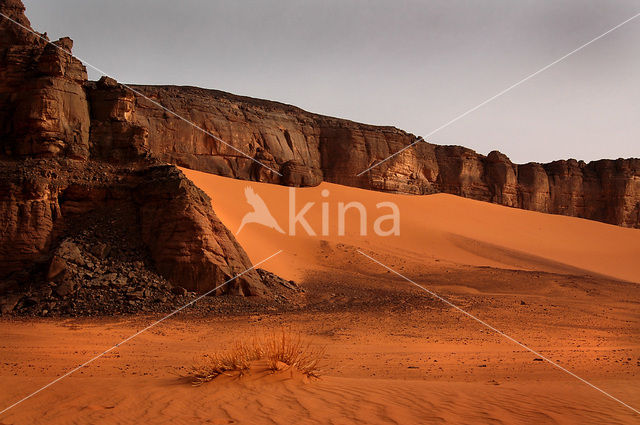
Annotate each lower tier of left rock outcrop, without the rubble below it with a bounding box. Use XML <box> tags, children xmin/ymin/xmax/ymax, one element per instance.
<box><xmin>0</xmin><ymin>158</ymin><xmax>265</xmax><ymax>295</ymax></box>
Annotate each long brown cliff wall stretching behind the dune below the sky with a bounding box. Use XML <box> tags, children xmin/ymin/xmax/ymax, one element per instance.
<box><xmin>100</xmin><ymin>82</ymin><xmax>640</xmax><ymax>227</ymax></box>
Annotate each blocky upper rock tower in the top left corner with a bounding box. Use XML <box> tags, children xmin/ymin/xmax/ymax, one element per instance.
<box><xmin>0</xmin><ymin>0</ymin><xmax>90</xmax><ymax>158</ymax></box>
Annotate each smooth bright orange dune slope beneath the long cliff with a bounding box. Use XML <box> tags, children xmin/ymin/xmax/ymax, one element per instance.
<box><xmin>183</xmin><ymin>169</ymin><xmax>640</xmax><ymax>282</ymax></box>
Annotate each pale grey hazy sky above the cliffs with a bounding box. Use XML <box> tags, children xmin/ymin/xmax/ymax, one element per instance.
<box><xmin>24</xmin><ymin>0</ymin><xmax>640</xmax><ymax>162</ymax></box>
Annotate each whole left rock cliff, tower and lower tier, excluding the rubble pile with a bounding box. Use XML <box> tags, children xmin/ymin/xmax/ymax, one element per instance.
<box><xmin>0</xmin><ymin>0</ymin><xmax>265</xmax><ymax>302</ymax></box>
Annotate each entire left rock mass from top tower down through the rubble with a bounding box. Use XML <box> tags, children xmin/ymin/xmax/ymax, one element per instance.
<box><xmin>0</xmin><ymin>0</ymin><xmax>298</xmax><ymax>314</ymax></box>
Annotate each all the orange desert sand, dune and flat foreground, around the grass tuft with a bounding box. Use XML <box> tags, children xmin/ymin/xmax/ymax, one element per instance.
<box><xmin>0</xmin><ymin>170</ymin><xmax>640</xmax><ymax>424</ymax></box>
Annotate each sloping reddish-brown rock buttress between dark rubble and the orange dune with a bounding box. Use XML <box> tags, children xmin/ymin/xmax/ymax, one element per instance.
<box><xmin>136</xmin><ymin>166</ymin><xmax>265</xmax><ymax>295</ymax></box>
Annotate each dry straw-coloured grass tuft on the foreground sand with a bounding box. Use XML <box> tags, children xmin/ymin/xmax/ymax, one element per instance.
<box><xmin>187</xmin><ymin>331</ymin><xmax>325</xmax><ymax>385</ymax></box>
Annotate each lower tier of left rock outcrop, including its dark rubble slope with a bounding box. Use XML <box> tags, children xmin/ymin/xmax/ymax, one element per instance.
<box><xmin>0</xmin><ymin>159</ymin><xmax>302</xmax><ymax>315</ymax></box>
